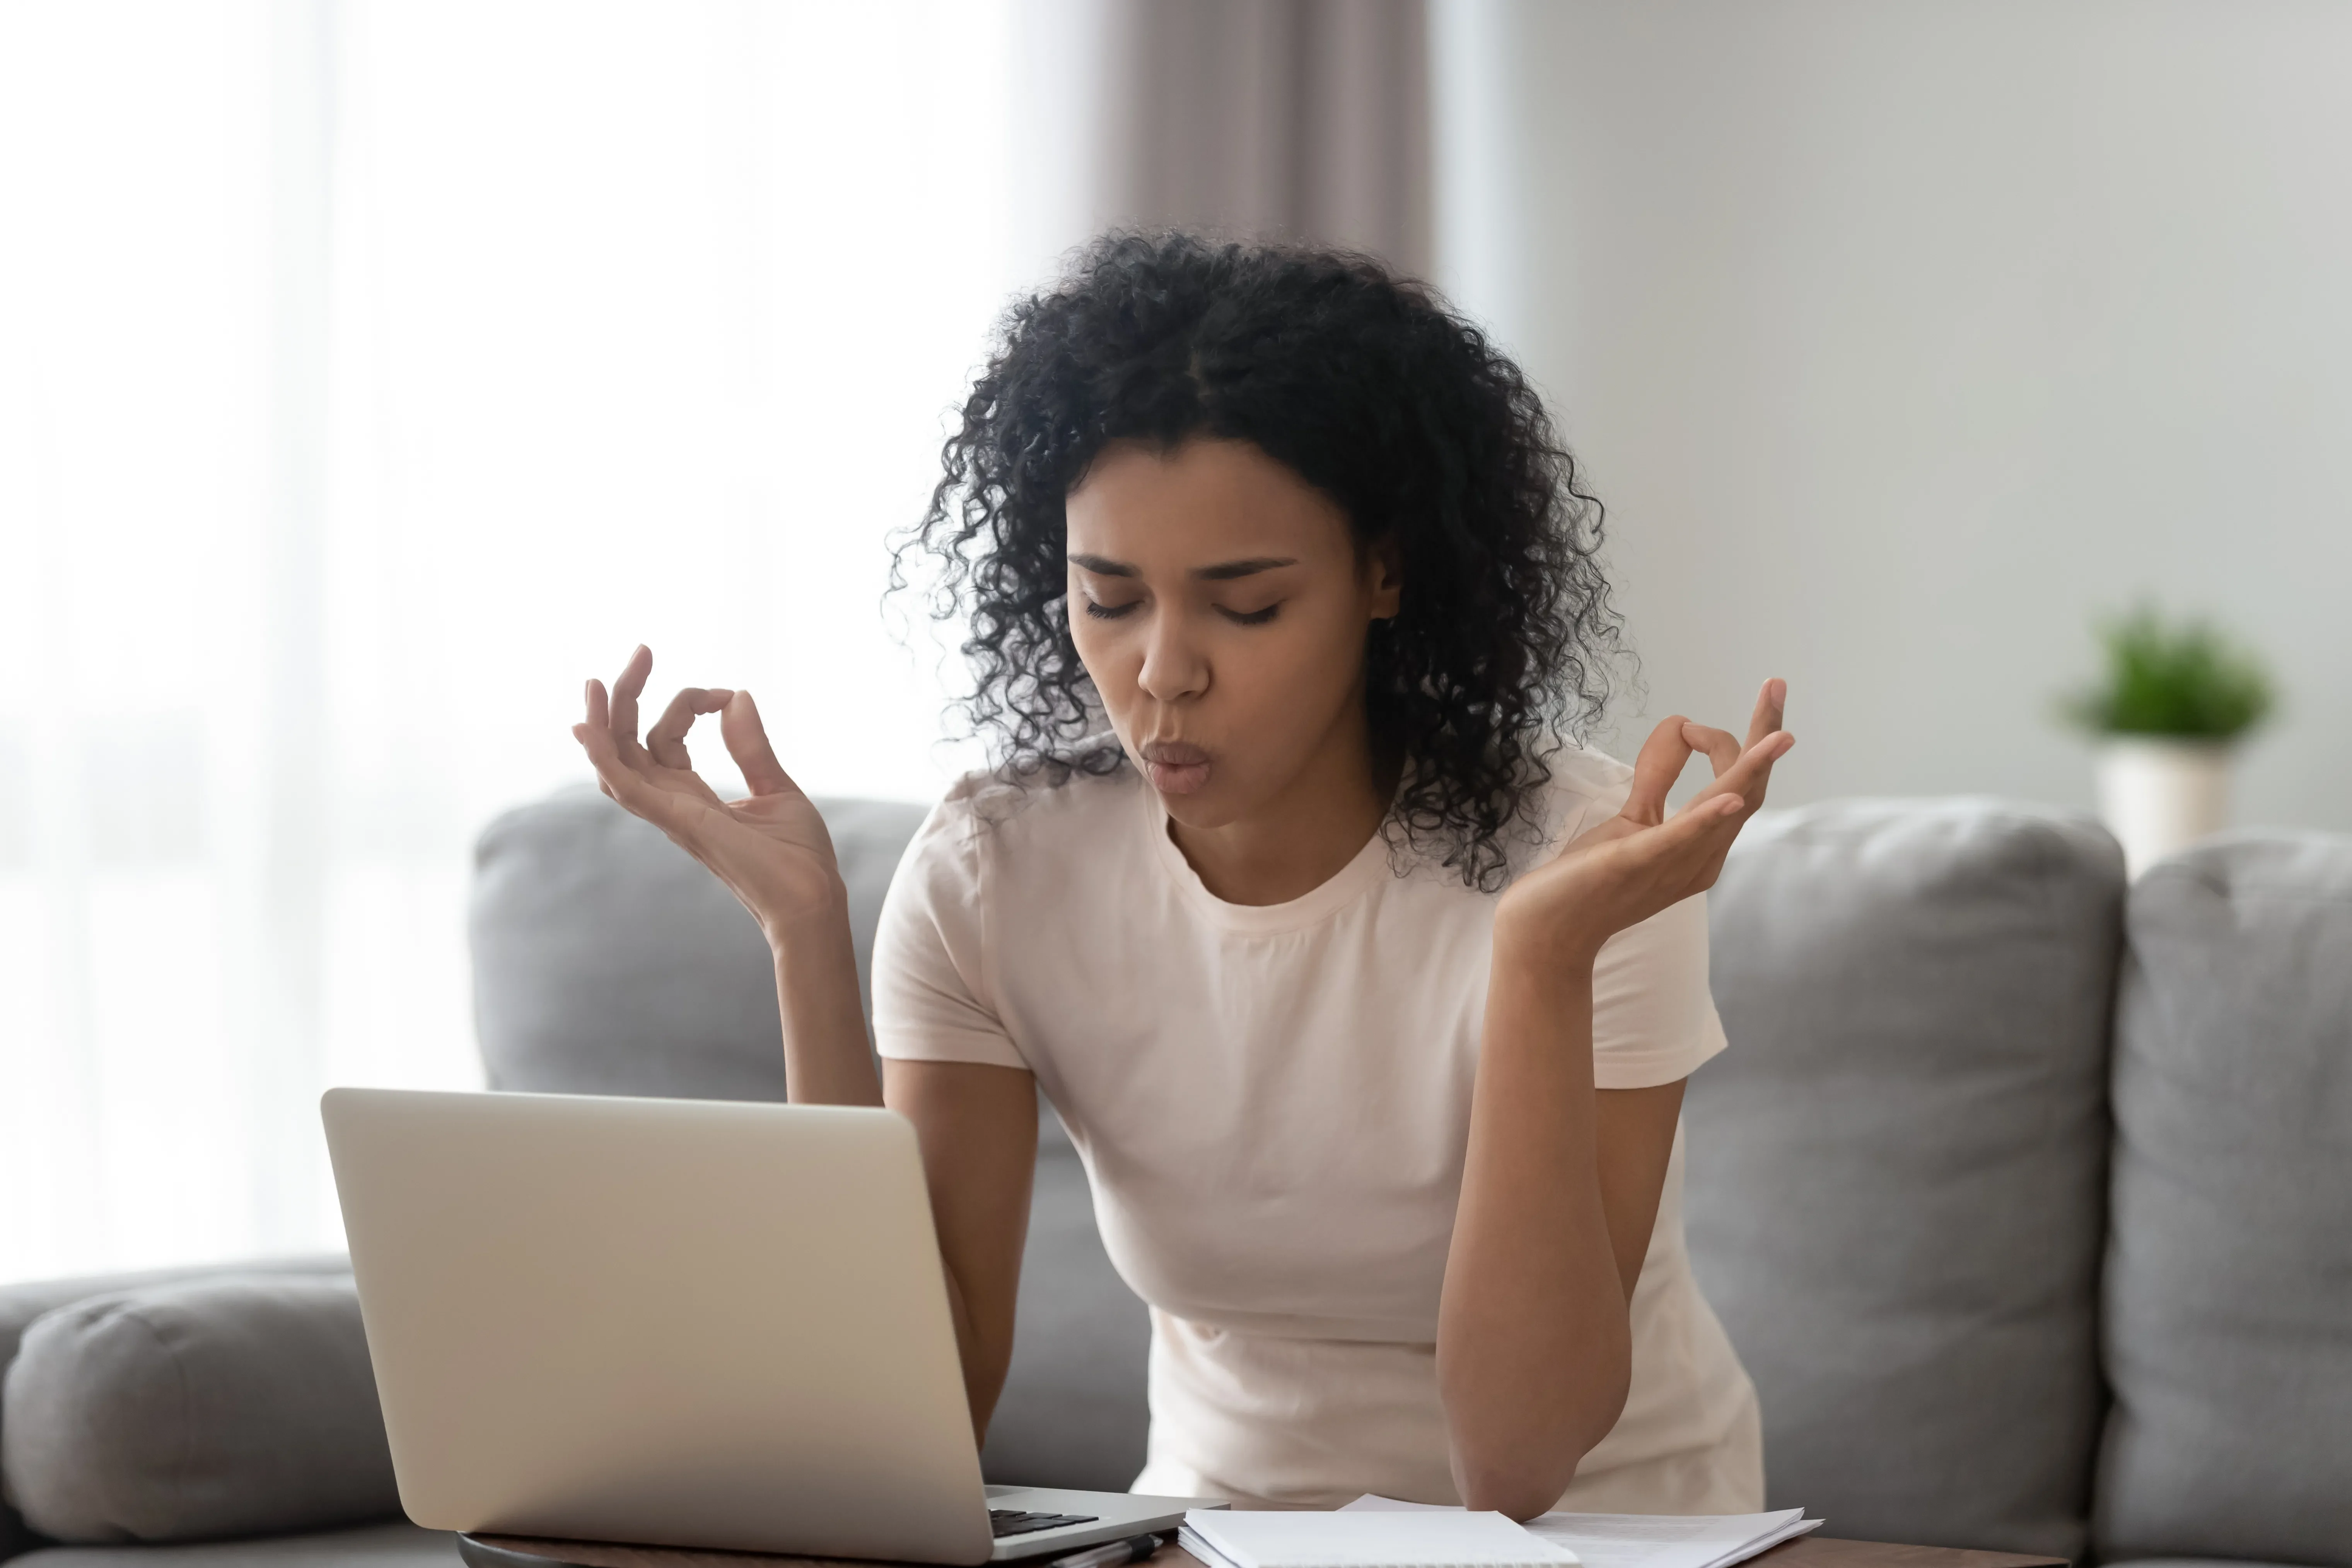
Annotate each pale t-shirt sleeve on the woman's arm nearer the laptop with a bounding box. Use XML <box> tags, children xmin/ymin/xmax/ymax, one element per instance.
<box><xmin>872</xmin><ymin>792</ymin><xmax>1028</xmax><ymax>1070</ymax></box>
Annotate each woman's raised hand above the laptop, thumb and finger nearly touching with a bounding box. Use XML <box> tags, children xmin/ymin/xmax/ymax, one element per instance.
<box><xmin>572</xmin><ymin>647</ymin><xmax>847</xmax><ymax>952</ymax></box>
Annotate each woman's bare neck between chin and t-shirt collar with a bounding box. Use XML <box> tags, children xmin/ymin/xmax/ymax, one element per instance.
<box><xmin>1169</xmin><ymin>703</ymin><xmax>1397</xmax><ymax>905</ymax></box>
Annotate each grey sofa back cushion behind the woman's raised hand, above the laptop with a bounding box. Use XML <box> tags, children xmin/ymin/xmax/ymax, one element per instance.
<box><xmin>470</xmin><ymin>785</ymin><xmax>924</xmax><ymax>1100</ymax></box>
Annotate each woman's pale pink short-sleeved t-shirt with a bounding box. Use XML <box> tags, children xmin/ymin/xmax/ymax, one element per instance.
<box><xmin>872</xmin><ymin>750</ymin><xmax>1764</xmax><ymax>1514</ymax></box>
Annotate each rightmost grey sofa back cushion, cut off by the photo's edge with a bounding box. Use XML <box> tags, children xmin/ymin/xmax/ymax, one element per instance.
<box><xmin>2098</xmin><ymin>832</ymin><xmax>2352</xmax><ymax>1566</ymax></box>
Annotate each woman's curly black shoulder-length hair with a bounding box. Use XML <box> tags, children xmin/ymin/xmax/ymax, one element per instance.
<box><xmin>891</xmin><ymin>233</ymin><xmax>1623</xmax><ymax>889</ymax></box>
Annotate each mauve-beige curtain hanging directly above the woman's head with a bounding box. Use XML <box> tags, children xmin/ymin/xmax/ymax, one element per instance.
<box><xmin>1016</xmin><ymin>0</ymin><xmax>1430</xmax><ymax>273</ymax></box>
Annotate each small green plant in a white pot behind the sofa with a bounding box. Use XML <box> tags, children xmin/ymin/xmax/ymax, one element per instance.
<box><xmin>2060</xmin><ymin>604</ymin><xmax>2274</xmax><ymax>877</ymax></box>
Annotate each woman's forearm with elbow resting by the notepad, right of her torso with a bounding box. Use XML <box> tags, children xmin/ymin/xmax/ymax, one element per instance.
<box><xmin>1437</xmin><ymin>943</ymin><xmax>1632</xmax><ymax>1519</ymax></box>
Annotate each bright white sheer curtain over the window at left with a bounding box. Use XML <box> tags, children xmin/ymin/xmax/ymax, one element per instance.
<box><xmin>0</xmin><ymin>0</ymin><xmax>1030</xmax><ymax>1279</ymax></box>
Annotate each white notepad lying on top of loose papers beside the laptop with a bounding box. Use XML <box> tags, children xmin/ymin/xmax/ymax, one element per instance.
<box><xmin>1195</xmin><ymin>1509</ymin><xmax>1576</xmax><ymax>1568</ymax></box>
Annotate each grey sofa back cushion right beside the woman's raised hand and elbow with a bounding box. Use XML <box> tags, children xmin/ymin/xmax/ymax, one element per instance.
<box><xmin>1686</xmin><ymin>799</ymin><xmax>2124</xmax><ymax>1561</ymax></box>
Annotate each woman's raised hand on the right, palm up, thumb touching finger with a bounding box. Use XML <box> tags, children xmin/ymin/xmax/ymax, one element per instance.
<box><xmin>1496</xmin><ymin>679</ymin><xmax>1797</xmax><ymax>961</ymax></box>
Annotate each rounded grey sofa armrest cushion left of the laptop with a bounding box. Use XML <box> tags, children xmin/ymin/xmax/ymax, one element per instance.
<box><xmin>0</xmin><ymin>1274</ymin><xmax>400</xmax><ymax>1542</ymax></box>
